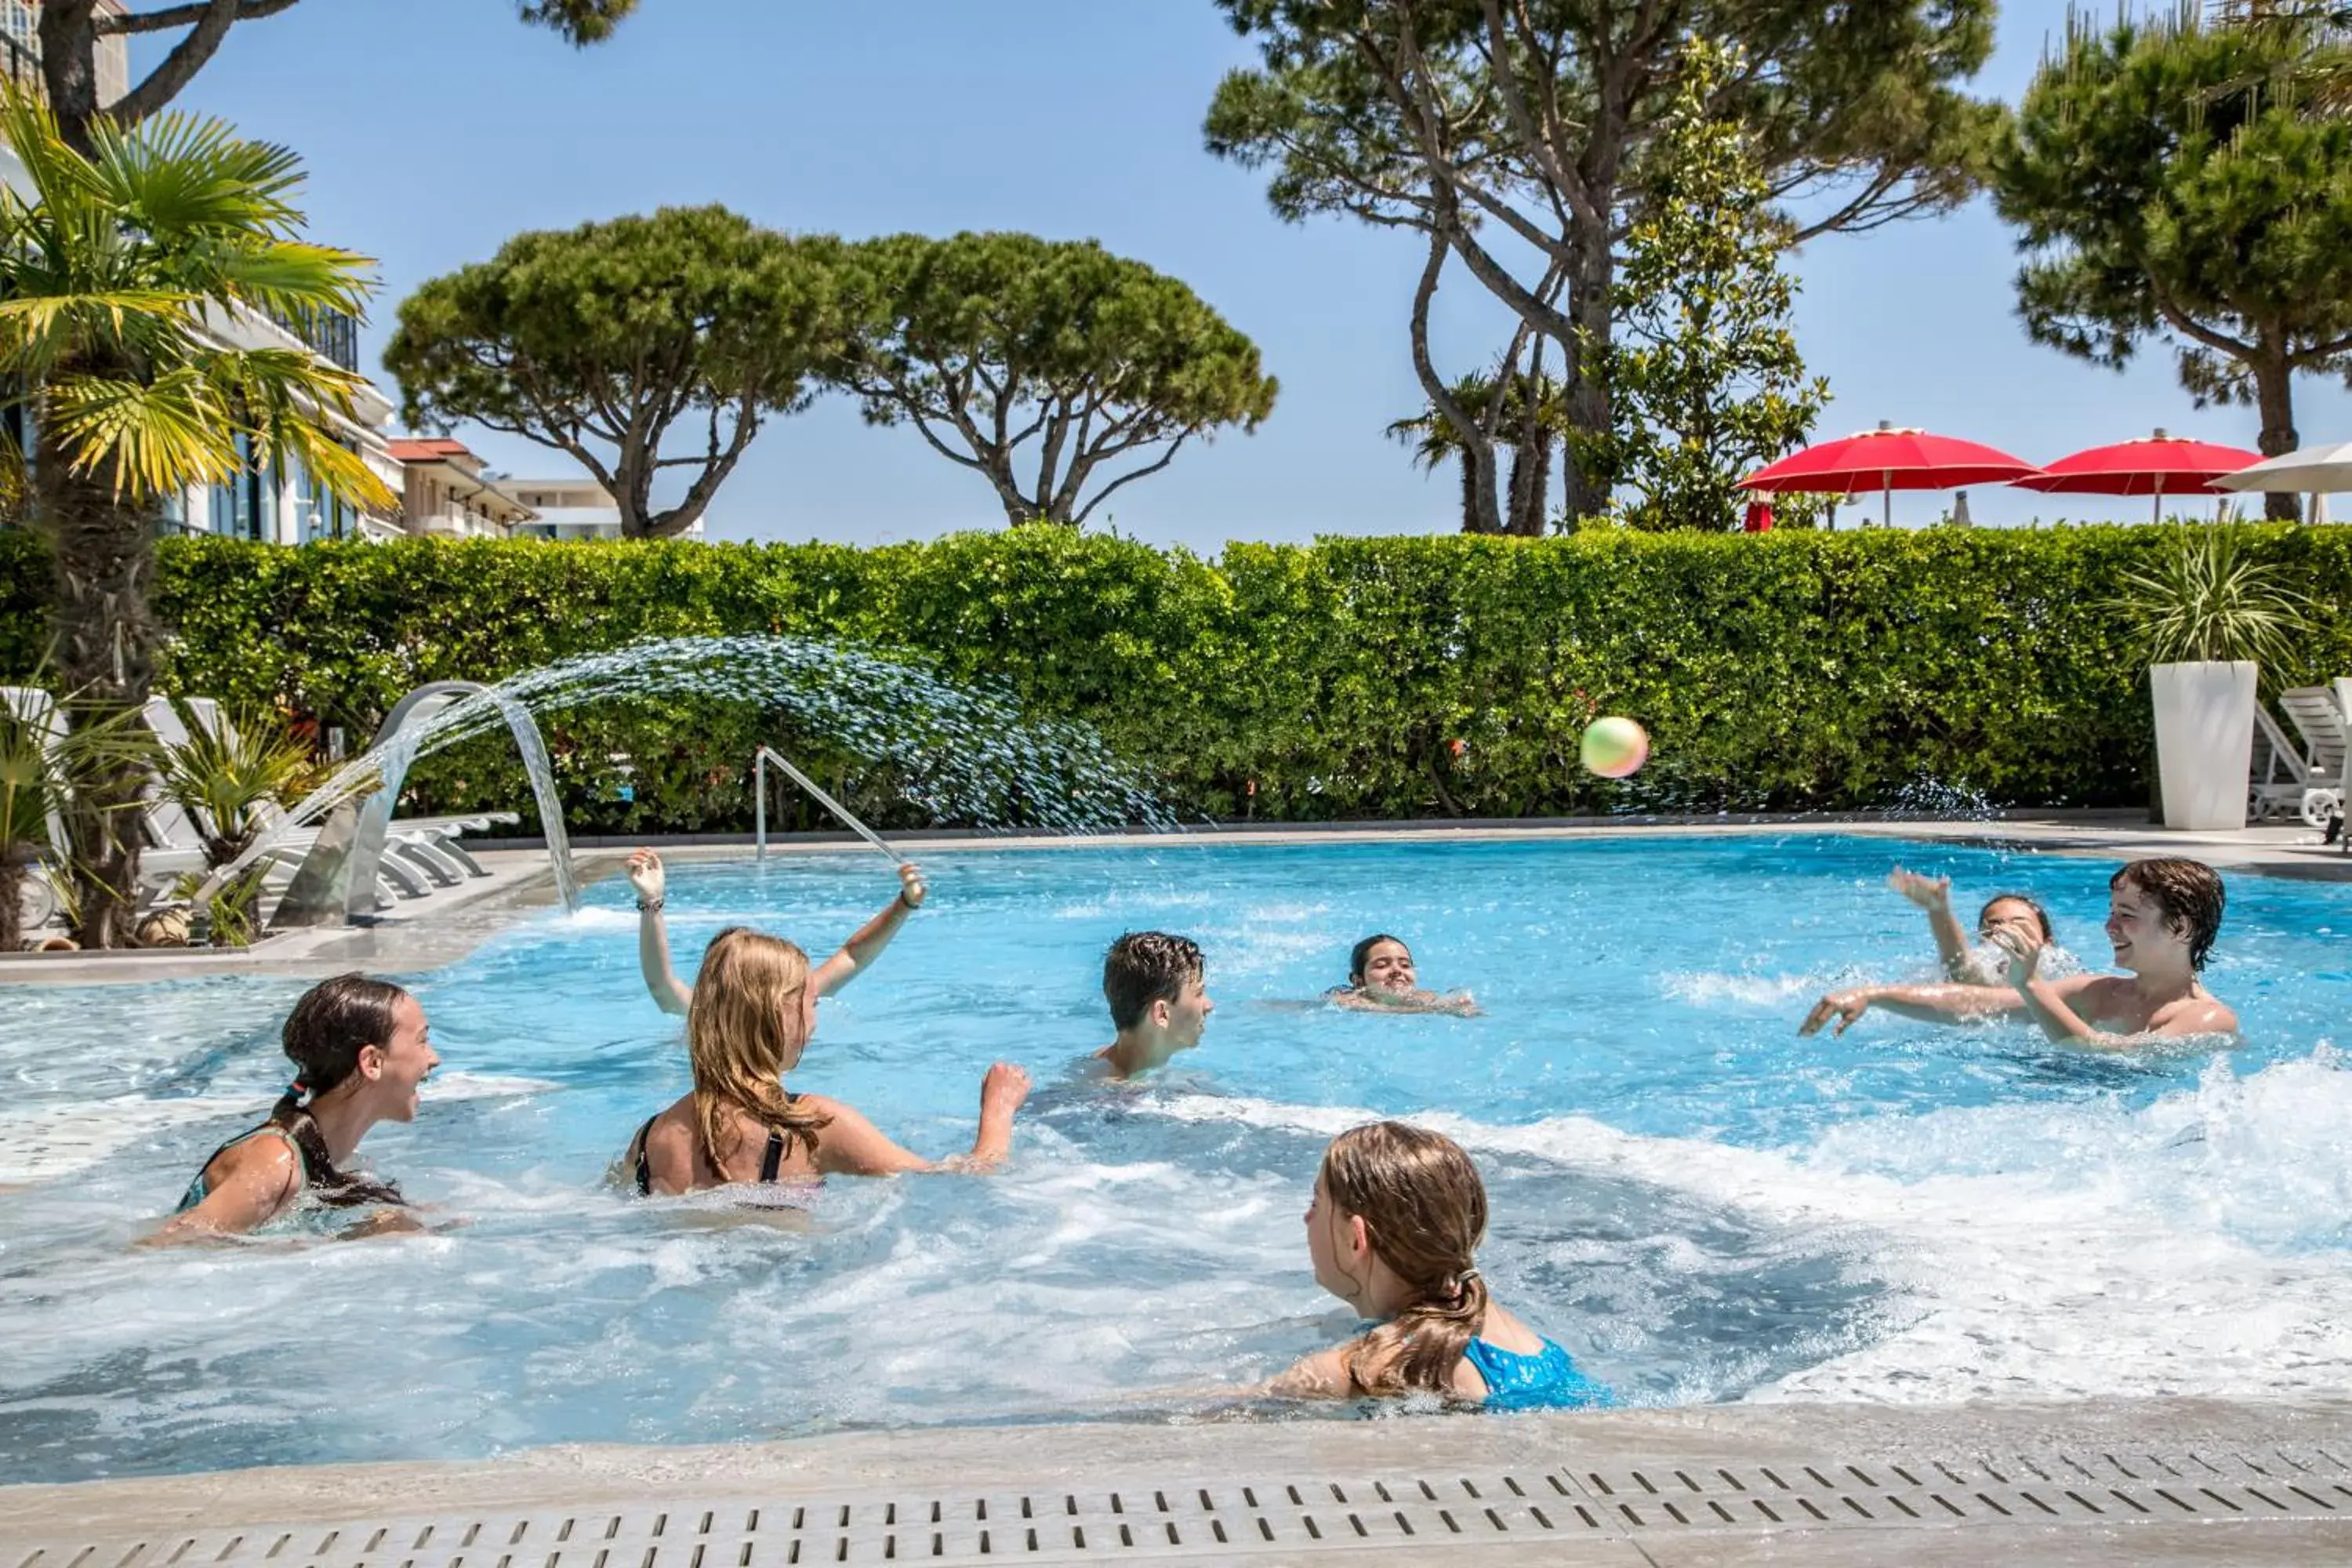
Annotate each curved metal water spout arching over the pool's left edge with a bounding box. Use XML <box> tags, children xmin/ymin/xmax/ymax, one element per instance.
<box><xmin>270</xmin><ymin>682</ymin><xmax>581</xmax><ymax>926</ymax></box>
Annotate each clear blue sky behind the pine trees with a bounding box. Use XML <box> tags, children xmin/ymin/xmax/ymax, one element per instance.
<box><xmin>156</xmin><ymin>0</ymin><xmax>2352</xmax><ymax>550</ymax></box>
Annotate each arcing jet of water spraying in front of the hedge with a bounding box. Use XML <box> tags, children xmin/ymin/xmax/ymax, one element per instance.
<box><xmin>219</xmin><ymin>635</ymin><xmax>1181</xmax><ymax>902</ymax></box>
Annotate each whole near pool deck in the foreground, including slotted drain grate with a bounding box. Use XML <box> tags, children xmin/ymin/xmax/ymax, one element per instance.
<box><xmin>0</xmin><ymin>1401</ymin><xmax>2352</xmax><ymax>1568</ymax></box>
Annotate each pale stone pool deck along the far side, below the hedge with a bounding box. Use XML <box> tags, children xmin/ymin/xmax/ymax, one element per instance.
<box><xmin>0</xmin><ymin>811</ymin><xmax>2352</xmax><ymax>987</ymax></box>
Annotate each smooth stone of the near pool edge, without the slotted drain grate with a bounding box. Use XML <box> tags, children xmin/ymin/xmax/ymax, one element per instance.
<box><xmin>0</xmin><ymin>1399</ymin><xmax>2352</xmax><ymax>1566</ymax></box>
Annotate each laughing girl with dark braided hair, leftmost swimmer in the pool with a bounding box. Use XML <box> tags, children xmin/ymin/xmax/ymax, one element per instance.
<box><xmin>158</xmin><ymin>975</ymin><xmax>440</xmax><ymax>1241</ymax></box>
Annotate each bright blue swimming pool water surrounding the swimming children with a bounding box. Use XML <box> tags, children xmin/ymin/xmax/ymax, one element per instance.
<box><xmin>0</xmin><ymin>834</ymin><xmax>2352</xmax><ymax>1481</ymax></box>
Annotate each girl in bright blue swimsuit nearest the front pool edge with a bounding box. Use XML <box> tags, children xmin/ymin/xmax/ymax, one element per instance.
<box><xmin>1268</xmin><ymin>1121</ymin><xmax>1611</xmax><ymax>1410</ymax></box>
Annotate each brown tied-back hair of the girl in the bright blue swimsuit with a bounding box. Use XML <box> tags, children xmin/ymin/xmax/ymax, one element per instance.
<box><xmin>1322</xmin><ymin>1121</ymin><xmax>1486</xmax><ymax>1394</ymax></box>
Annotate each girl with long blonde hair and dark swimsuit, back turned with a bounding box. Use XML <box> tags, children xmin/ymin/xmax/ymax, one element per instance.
<box><xmin>621</xmin><ymin>926</ymin><xmax>1030</xmax><ymax>1196</ymax></box>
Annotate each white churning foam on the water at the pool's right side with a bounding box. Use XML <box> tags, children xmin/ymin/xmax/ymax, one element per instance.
<box><xmin>1160</xmin><ymin>1048</ymin><xmax>2352</xmax><ymax>1401</ymax></box>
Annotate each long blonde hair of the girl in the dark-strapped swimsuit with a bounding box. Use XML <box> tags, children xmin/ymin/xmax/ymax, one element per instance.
<box><xmin>687</xmin><ymin>926</ymin><xmax>833</xmax><ymax>1178</ymax></box>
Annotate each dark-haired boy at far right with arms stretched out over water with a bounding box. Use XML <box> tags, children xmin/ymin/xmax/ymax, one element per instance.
<box><xmin>1797</xmin><ymin>858</ymin><xmax>2237</xmax><ymax>1051</ymax></box>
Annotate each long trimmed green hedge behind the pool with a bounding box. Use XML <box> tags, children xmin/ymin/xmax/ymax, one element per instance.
<box><xmin>0</xmin><ymin>527</ymin><xmax>2352</xmax><ymax>832</ymax></box>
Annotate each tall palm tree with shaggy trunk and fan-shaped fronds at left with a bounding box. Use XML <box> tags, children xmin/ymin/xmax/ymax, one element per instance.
<box><xmin>0</xmin><ymin>89</ymin><xmax>390</xmax><ymax>947</ymax></box>
